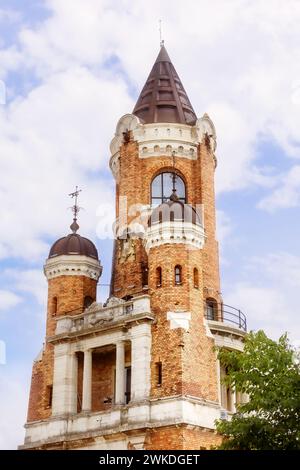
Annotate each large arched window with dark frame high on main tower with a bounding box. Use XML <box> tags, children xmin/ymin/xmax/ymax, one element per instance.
<box><xmin>151</xmin><ymin>172</ymin><xmax>186</xmax><ymax>205</ymax></box>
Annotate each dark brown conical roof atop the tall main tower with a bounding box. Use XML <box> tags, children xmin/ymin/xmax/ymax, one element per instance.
<box><xmin>133</xmin><ymin>45</ymin><xmax>197</xmax><ymax>125</ymax></box>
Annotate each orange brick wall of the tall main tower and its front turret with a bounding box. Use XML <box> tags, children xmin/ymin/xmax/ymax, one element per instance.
<box><xmin>112</xmin><ymin>136</ymin><xmax>220</xmax><ymax>401</ymax></box>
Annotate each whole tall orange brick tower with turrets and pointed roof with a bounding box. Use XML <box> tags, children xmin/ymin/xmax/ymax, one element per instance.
<box><xmin>22</xmin><ymin>45</ymin><xmax>246</xmax><ymax>449</ymax></box>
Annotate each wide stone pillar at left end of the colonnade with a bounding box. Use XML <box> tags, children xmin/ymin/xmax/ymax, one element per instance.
<box><xmin>52</xmin><ymin>344</ymin><xmax>78</xmax><ymax>416</ymax></box>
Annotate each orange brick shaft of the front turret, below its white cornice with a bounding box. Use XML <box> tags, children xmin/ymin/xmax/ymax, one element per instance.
<box><xmin>149</xmin><ymin>244</ymin><xmax>218</xmax><ymax>401</ymax></box>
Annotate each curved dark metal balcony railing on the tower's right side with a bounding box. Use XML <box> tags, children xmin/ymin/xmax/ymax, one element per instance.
<box><xmin>205</xmin><ymin>303</ymin><xmax>247</xmax><ymax>331</ymax></box>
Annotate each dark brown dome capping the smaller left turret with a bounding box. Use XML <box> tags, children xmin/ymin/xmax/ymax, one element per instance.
<box><xmin>49</xmin><ymin>233</ymin><xmax>99</xmax><ymax>260</ymax></box>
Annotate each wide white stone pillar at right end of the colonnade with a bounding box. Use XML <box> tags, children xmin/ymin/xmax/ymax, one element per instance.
<box><xmin>131</xmin><ymin>323</ymin><xmax>151</xmax><ymax>401</ymax></box>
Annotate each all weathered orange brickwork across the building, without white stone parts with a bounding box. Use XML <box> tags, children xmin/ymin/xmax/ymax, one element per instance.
<box><xmin>28</xmin><ymin>129</ymin><xmax>220</xmax><ymax>449</ymax></box>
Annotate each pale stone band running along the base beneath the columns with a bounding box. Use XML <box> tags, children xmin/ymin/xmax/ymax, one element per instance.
<box><xmin>21</xmin><ymin>397</ymin><xmax>222</xmax><ymax>449</ymax></box>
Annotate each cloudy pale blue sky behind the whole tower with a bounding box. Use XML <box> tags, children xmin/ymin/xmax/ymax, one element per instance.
<box><xmin>0</xmin><ymin>0</ymin><xmax>300</xmax><ymax>449</ymax></box>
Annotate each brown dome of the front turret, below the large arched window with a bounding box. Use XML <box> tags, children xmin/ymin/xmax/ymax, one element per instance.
<box><xmin>148</xmin><ymin>200</ymin><xmax>202</xmax><ymax>227</ymax></box>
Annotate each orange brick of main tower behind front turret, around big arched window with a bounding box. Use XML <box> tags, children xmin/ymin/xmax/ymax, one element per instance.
<box><xmin>112</xmin><ymin>136</ymin><xmax>219</xmax><ymax>297</ymax></box>
